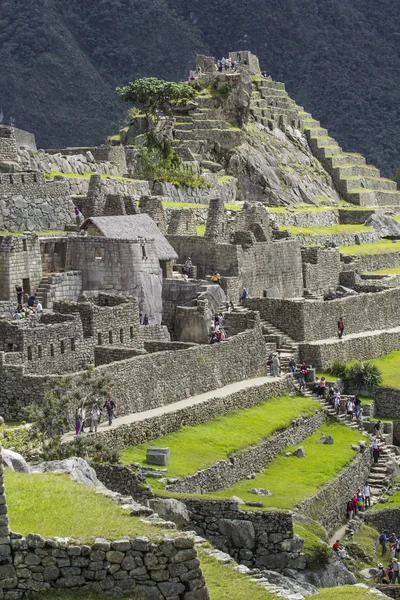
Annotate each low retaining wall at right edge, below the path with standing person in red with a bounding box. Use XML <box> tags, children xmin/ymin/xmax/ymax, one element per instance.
<box><xmin>299</xmin><ymin>327</ymin><xmax>400</xmax><ymax>368</ymax></box>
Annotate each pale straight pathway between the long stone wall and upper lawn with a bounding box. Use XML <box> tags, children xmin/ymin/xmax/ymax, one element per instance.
<box><xmin>63</xmin><ymin>375</ymin><xmax>286</xmax><ymax>442</ymax></box>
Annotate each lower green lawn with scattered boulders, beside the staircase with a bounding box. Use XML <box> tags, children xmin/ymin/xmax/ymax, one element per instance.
<box><xmin>208</xmin><ymin>423</ymin><xmax>366</xmax><ymax>509</ymax></box>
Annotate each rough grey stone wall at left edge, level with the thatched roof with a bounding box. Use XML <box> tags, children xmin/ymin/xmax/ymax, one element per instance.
<box><xmin>0</xmin><ymin>172</ymin><xmax>75</xmax><ymax>231</ymax></box>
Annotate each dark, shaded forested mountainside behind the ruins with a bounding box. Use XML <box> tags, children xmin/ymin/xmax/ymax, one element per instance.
<box><xmin>0</xmin><ymin>0</ymin><xmax>400</xmax><ymax>174</ymax></box>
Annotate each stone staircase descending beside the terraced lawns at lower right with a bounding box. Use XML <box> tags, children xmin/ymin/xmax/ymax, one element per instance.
<box><xmin>300</xmin><ymin>389</ymin><xmax>400</xmax><ymax>504</ymax></box>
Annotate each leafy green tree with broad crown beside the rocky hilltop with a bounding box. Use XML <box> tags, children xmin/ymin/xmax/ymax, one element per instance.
<box><xmin>116</xmin><ymin>77</ymin><xmax>197</xmax><ymax>120</ymax></box>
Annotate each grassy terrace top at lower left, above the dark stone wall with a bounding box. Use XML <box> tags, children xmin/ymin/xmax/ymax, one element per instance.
<box><xmin>5</xmin><ymin>469</ymin><xmax>160</xmax><ymax>542</ymax></box>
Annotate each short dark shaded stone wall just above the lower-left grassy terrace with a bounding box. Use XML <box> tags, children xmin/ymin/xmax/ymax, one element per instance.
<box><xmin>91</xmin><ymin>463</ymin><xmax>154</xmax><ymax>501</ymax></box>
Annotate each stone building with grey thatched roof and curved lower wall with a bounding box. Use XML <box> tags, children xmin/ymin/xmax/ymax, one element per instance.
<box><xmin>66</xmin><ymin>214</ymin><xmax>177</xmax><ymax>324</ymax></box>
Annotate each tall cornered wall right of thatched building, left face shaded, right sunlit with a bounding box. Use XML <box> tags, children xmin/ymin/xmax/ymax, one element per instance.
<box><xmin>167</xmin><ymin>236</ymin><xmax>303</xmax><ymax>301</ymax></box>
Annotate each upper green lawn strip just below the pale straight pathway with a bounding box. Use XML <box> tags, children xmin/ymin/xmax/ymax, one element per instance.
<box><xmin>121</xmin><ymin>396</ymin><xmax>321</xmax><ymax>477</ymax></box>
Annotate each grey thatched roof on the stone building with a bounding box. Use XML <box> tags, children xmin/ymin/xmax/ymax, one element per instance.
<box><xmin>81</xmin><ymin>214</ymin><xmax>178</xmax><ymax>260</ymax></box>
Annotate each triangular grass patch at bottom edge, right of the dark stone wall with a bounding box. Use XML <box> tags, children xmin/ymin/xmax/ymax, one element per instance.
<box><xmin>198</xmin><ymin>548</ymin><xmax>278</xmax><ymax>600</ymax></box>
